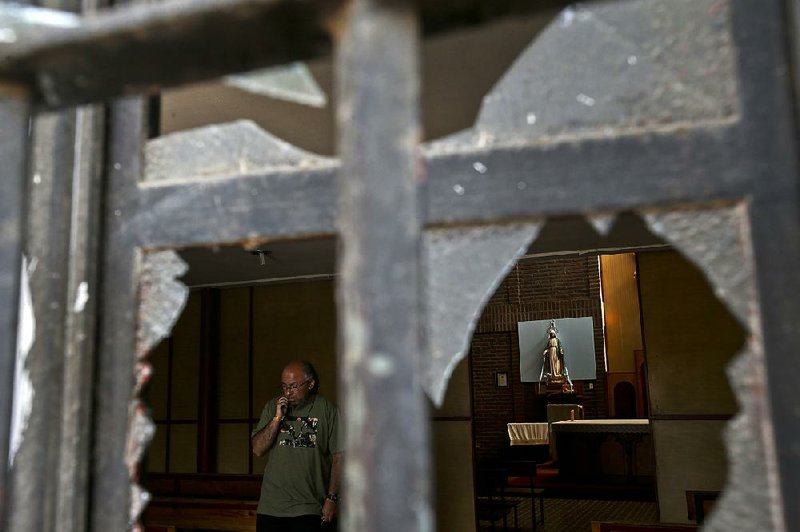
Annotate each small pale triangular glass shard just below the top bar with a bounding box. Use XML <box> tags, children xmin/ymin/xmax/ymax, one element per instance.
<box><xmin>223</xmin><ymin>63</ymin><xmax>328</xmax><ymax>107</ymax></box>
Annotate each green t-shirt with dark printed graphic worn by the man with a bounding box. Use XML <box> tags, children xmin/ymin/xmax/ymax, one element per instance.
<box><xmin>251</xmin><ymin>394</ymin><xmax>341</xmax><ymax>517</ymax></box>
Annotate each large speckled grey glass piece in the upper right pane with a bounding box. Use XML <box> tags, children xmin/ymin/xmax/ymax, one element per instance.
<box><xmin>429</xmin><ymin>0</ymin><xmax>738</xmax><ymax>152</ymax></box>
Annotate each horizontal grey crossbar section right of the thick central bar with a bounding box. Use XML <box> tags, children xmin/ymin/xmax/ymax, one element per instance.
<box><xmin>423</xmin><ymin>124</ymin><xmax>754</xmax><ymax>225</ymax></box>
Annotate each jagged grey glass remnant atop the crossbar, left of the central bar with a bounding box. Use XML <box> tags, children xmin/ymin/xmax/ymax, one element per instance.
<box><xmin>144</xmin><ymin>120</ymin><xmax>335</xmax><ymax>182</ymax></box>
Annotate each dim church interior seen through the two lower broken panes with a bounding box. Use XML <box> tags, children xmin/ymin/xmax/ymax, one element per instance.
<box><xmin>136</xmin><ymin>227</ymin><xmax>744</xmax><ymax>531</ymax></box>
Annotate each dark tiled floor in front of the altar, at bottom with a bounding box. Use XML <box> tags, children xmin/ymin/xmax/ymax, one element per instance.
<box><xmin>480</xmin><ymin>499</ymin><xmax>658</xmax><ymax>532</ymax></box>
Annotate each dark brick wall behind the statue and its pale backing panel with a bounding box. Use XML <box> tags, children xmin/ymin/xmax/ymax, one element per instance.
<box><xmin>470</xmin><ymin>255</ymin><xmax>607</xmax><ymax>459</ymax></box>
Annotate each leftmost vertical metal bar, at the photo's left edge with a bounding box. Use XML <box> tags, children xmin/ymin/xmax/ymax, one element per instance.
<box><xmin>0</xmin><ymin>94</ymin><xmax>29</xmax><ymax>530</ymax></box>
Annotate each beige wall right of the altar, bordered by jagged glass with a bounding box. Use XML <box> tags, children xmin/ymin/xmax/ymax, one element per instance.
<box><xmin>639</xmin><ymin>251</ymin><xmax>744</xmax><ymax>522</ymax></box>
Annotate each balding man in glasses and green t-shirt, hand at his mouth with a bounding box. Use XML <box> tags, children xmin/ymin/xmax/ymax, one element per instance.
<box><xmin>251</xmin><ymin>361</ymin><xmax>342</xmax><ymax>532</ymax></box>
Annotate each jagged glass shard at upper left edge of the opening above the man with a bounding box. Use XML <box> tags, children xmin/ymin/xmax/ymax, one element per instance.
<box><xmin>136</xmin><ymin>250</ymin><xmax>189</xmax><ymax>359</ymax></box>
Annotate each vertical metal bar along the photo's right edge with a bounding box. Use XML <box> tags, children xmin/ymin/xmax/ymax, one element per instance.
<box><xmin>733</xmin><ymin>0</ymin><xmax>800</xmax><ymax>530</ymax></box>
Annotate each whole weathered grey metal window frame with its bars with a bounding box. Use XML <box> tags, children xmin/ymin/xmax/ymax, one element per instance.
<box><xmin>0</xmin><ymin>0</ymin><xmax>800</xmax><ymax>531</ymax></box>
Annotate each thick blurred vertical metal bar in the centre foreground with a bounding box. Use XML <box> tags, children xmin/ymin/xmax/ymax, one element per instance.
<box><xmin>337</xmin><ymin>0</ymin><xmax>433</xmax><ymax>532</ymax></box>
